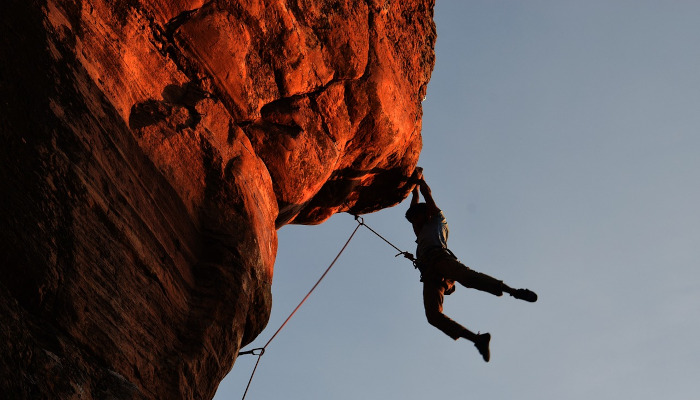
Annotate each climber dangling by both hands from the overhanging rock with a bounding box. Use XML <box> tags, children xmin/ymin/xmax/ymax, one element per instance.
<box><xmin>406</xmin><ymin>168</ymin><xmax>537</xmax><ymax>362</ymax></box>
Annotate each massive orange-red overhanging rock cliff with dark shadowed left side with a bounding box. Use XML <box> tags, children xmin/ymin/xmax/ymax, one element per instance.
<box><xmin>0</xmin><ymin>0</ymin><xmax>435</xmax><ymax>399</ymax></box>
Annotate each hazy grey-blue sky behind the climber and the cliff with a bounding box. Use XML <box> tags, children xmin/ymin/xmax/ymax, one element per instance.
<box><xmin>215</xmin><ymin>0</ymin><xmax>700</xmax><ymax>400</ymax></box>
